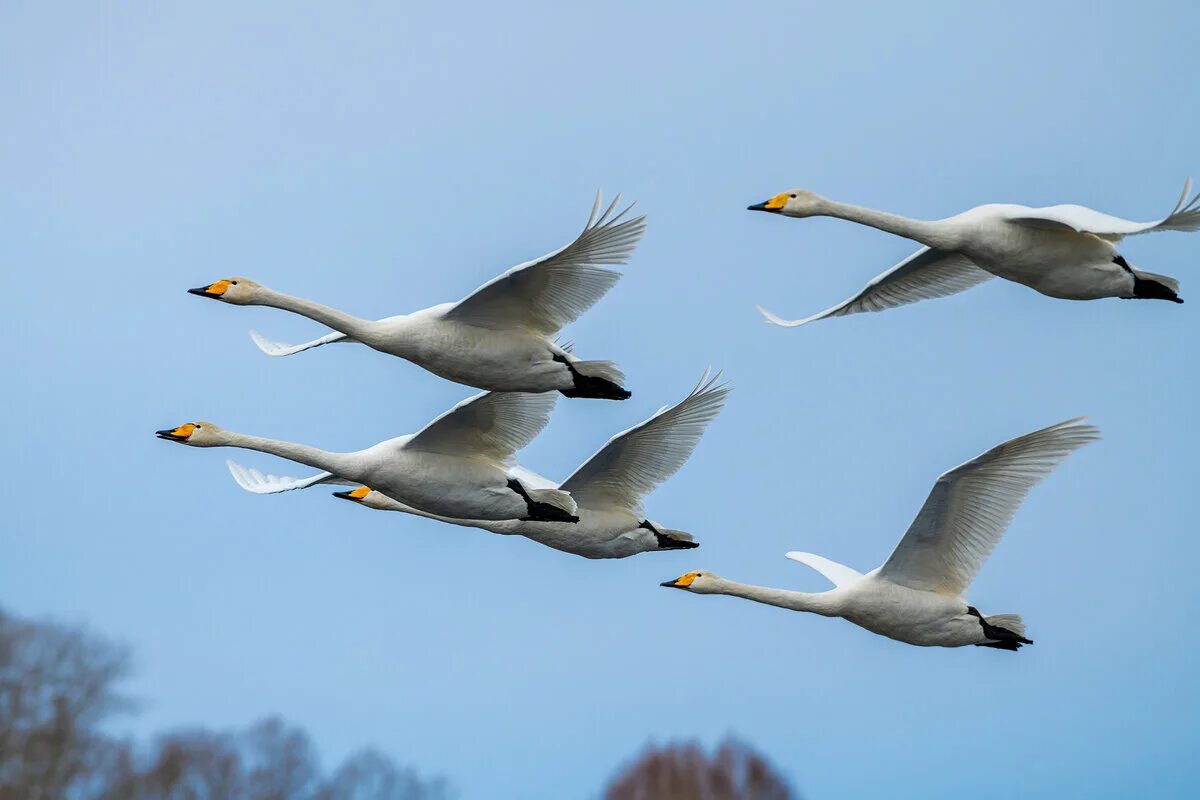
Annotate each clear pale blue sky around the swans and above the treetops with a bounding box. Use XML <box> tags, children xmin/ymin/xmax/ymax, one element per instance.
<box><xmin>0</xmin><ymin>0</ymin><xmax>1200</xmax><ymax>798</ymax></box>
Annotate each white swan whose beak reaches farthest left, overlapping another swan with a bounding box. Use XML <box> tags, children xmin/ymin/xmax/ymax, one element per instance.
<box><xmin>156</xmin><ymin>392</ymin><xmax>578</xmax><ymax>523</ymax></box>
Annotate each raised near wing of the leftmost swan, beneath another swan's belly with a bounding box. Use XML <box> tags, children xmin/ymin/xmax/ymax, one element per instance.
<box><xmin>404</xmin><ymin>392</ymin><xmax>558</xmax><ymax>462</ymax></box>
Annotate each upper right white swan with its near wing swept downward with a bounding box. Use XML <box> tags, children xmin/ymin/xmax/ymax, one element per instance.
<box><xmin>749</xmin><ymin>179</ymin><xmax>1200</xmax><ymax>327</ymax></box>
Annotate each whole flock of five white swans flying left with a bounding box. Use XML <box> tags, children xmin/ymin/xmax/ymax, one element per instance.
<box><xmin>156</xmin><ymin>181</ymin><xmax>1200</xmax><ymax>650</ymax></box>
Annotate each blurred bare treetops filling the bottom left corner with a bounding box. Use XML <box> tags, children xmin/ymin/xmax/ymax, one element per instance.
<box><xmin>0</xmin><ymin>610</ymin><xmax>450</xmax><ymax>800</ymax></box>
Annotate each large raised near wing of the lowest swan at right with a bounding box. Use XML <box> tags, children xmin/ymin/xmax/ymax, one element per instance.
<box><xmin>878</xmin><ymin>420</ymin><xmax>1100</xmax><ymax>596</ymax></box>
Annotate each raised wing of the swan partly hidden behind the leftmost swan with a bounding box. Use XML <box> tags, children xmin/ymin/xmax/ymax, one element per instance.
<box><xmin>558</xmin><ymin>371</ymin><xmax>730</xmax><ymax>515</ymax></box>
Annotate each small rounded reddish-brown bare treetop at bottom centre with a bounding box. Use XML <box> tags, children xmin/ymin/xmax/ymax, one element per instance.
<box><xmin>604</xmin><ymin>739</ymin><xmax>797</xmax><ymax>800</ymax></box>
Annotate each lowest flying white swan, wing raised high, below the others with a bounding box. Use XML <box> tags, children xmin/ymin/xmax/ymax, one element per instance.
<box><xmin>661</xmin><ymin>420</ymin><xmax>1099</xmax><ymax>650</ymax></box>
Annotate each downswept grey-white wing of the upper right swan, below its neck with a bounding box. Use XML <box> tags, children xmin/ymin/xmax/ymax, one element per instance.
<box><xmin>758</xmin><ymin>247</ymin><xmax>992</xmax><ymax>327</ymax></box>
